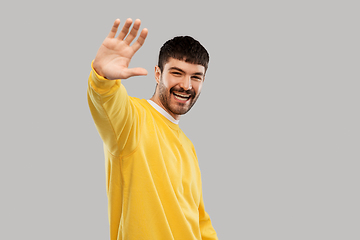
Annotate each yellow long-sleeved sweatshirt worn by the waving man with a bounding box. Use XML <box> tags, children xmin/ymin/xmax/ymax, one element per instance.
<box><xmin>88</xmin><ymin>64</ymin><xmax>218</xmax><ymax>240</ymax></box>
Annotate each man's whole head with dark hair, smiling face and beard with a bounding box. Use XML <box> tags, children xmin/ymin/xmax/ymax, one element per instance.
<box><xmin>152</xmin><ymin>36</ymin><xmax>209</xmax><ymax>119</ymax></box>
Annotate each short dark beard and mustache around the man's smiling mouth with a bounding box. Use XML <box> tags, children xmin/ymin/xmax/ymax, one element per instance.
<box><xmin>159</xmin><ymin>76</ymin><xmax>200</xmax><ymax>115</ymax></box>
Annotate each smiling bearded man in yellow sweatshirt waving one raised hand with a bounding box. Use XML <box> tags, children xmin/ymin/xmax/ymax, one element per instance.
<box><xmin>88</xmin><ymin>19</ymin><xmax>218</xmax><ymax>240</ymax></box>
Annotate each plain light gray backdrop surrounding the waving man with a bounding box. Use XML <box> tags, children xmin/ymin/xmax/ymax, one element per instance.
<box><xmin>0</xmin><ymin>0</ymin><xmax>360</xmax><ymax>240</ymax></box>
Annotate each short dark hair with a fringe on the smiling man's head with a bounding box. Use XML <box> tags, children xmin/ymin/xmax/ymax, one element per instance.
<box><xmin>158</xmin><ymin>36</ymin><xmax>209</xmax><ymax>72</ymax></box>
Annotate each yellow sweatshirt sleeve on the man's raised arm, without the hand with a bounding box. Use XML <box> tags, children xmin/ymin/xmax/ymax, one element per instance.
<box><xmin>87</xmin><ymin>61</ymin><xmax>139</xmax><ymax>156</ymax></box>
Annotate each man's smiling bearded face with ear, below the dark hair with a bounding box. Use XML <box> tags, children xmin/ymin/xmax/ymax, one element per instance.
<box><xmin>155</xmin><ymin>58</ymin><xmax>205</xmax><ymax>119</ymax></box>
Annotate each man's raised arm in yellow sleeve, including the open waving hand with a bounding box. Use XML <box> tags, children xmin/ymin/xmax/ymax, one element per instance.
<box><xmin>88</xmin><ymin>19</ymin><xmax>147</xmax><ymax>156</ymax></box>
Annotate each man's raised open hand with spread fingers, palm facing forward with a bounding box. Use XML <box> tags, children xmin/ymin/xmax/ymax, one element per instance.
<box><xmin>93</xmin><ymin>18</ymin><xmax>148</xmax><ymax>80</ymax></box>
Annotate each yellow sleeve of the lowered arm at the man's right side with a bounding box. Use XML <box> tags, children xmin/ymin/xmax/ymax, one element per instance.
<box><xmin>199</xmin><ymin>194</ymin><xmax>218</xmax><ymax>240</ymax></box>
